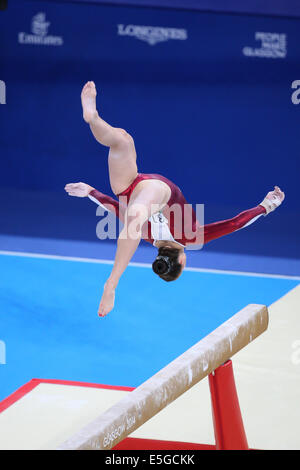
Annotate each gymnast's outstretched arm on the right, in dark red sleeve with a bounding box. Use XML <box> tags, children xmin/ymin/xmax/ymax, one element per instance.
<box><xmin>204</xmin><ymin>186</ymin><xmax>285</xmax><ymax>244</ymax></box>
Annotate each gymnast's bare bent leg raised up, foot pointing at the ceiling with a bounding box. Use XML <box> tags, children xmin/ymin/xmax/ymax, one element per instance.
<box><xmin>81</xmin><ymin>82</ymin><xmax>138</xmax><ymax>194</ymax></box>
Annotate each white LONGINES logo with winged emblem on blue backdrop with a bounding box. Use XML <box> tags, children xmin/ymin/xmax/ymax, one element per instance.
<box><xmin>118</xmin><ymin>24</ymin><xmax>188</xmax><ymax>46</ymax></box>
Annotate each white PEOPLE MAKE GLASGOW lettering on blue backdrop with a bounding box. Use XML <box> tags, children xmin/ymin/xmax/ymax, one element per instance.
<box><xmin>243</xmin><ymin>32</ymin><xmax>287</xmax><ymax>59</ymax></box>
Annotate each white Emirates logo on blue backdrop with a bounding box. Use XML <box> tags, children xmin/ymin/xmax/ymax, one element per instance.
<box><xmin>18</xmin><ymin>12</ymin><xmax>64</xmax><ymax>46</ymax></box>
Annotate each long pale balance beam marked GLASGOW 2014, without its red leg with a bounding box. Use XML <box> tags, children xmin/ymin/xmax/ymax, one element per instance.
<box><xmin>57</xmin><ymin>304</ymin><xmax>269</xmax><ymax>450</ymax></box>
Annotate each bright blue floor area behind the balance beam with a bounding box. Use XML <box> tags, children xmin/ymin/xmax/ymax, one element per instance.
<box><xmin>0</xmin><ymin>255</ymin><xmax>299</xmax><ymax>399</ymax></box>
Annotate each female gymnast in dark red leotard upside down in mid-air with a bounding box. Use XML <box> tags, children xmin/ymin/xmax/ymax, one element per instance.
<box><xmin>65</xmin><ymin>82</ymin><xmax>285</xmax><ymax>317</ymax></box>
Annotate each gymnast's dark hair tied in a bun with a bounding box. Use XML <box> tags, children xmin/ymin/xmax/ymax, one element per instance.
<box><xmin>152</xmin><ymin>247</ymin><xmax>183</xmax><ymax>282</ymax></box>
